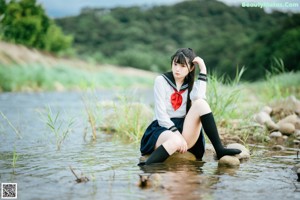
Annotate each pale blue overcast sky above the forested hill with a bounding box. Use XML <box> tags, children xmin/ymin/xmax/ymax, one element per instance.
<box><xmin>37</xmin><ymin>0</ymin><xmax>300</xmax><ymax>18</ymax></box>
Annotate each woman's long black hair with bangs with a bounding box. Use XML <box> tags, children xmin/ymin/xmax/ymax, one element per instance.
<box><xmin>171</xmin><ymin>48</ymin><xmax>196</xmax><ymax>112</ymax></box>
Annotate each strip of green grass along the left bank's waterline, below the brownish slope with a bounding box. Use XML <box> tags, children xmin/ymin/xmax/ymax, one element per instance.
<box><xmin>0</xmin><ymin>64</ymin><xmax>153</xmax><ymax>91</ymax></box>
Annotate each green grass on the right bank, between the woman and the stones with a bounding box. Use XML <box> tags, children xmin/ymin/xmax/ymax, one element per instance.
<box><xmin>203</xmin><ymin>65</ymin><xmax>300</xmax><ymax>144</ymax></box>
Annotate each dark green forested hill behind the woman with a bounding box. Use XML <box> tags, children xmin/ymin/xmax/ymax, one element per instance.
<box><xmin>56</xmin><ymin>0</ymin><xmax>300</xmax><ymax>80</ymax></box>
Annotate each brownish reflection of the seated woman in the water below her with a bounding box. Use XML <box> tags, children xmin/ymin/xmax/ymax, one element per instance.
<box><xmin>140</xmin><ymin>160</ymin><xmax>218</xmax><ymax>199</ymax></box>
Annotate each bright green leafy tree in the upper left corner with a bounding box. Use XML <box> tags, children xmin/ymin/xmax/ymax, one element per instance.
<box><xmin>0</xmin><ymin>0</ymin><xmax>72</xmax><ymax>52</ymax></box>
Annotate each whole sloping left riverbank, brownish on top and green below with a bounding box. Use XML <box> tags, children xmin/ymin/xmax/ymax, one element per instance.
<box><xmin>0</xmin><ymin>42</ymin><xmax>157</xmax><ymax>92</ymax></box>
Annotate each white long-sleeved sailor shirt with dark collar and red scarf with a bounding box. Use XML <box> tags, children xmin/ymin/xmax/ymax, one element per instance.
<box><xmin>154</xmin><ymin>72</ymin><xmax>207</xmax><ymax>131</ymax></box>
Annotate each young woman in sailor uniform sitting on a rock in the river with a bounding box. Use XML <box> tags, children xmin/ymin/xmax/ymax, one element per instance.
<box><xmin>139</xmin><ymin>48</ymin><xmax>241</xmax><ymax>165</ymax></box>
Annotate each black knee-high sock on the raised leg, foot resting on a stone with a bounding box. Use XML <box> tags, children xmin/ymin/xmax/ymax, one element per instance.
<box><xmin>200</xmin><ymin>113</ymin><xmax>241</xmax><ymax>159</ymax></box>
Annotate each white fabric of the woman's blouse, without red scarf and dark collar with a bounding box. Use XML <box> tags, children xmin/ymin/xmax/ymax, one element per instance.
<box><xmin>154</xmin><ymin>74</ymin><xmax>206</xmax><ymax>129</ymax></box>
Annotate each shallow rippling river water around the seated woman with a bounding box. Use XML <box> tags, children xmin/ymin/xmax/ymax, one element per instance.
<box><xmin>0</xmin><ymin>91</ymin><xmax>300</xmax><ymax>200</ymax></box>
